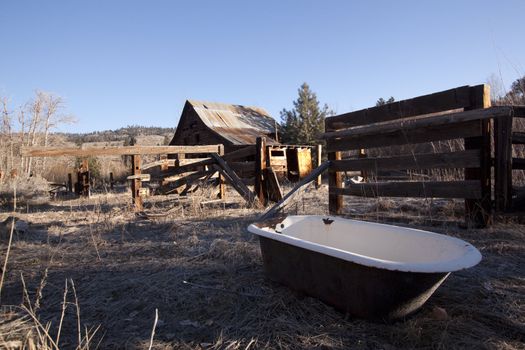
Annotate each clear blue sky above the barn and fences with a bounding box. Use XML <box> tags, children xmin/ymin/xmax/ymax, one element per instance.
<box><xmin>0</xmin><ymin>0</ymin><xmax>525</xmax><ymax>132</ymax></box>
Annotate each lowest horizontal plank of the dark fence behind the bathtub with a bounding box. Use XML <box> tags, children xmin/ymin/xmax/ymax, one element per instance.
<box><xmin>330</xmin><ymin>181</ymin><xmax>481</xmax><ymax>199</ymax></box>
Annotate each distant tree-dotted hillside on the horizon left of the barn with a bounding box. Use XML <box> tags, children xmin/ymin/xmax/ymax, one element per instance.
<box><xmin>61</xmin><ymin>125</ymin><xmax>175</xmax><ymax>145</ymax></box>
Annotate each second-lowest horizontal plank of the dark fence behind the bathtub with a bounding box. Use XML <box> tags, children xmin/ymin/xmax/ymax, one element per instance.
<box><xmin>330</xmin><ymin>150</ymin><xmax>480</xmax><ymax>171</ymax></box>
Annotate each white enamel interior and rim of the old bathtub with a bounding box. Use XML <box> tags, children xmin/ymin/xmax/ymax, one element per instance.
<box><xmin>250</xmin><ymin>215</ymin><xmax>481</xmax><ymax>272</ymax></box>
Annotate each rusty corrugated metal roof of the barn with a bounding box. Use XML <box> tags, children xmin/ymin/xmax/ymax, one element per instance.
<box><xmin>188</xmin><ymin>100</ymin><xmax>276</xmax><ymax>145</ymax></box>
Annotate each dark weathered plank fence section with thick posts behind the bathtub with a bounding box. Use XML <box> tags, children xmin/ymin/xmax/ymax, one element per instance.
<box><xmin>324</xmin><ymin>85</ymin><xmax>525</xmax><ymax>226</ymax></box>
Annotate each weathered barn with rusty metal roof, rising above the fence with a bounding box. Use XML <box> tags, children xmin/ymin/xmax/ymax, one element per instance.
<box><xmin>170</xmin><ymin>100</ymin><xmax>278</xmax><ymax>153</ymax></box>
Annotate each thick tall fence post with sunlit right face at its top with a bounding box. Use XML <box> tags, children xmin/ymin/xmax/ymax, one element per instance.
<box><xmin>464</xmin><ymin>84</ymin><xmax>492</xmax><ymax>227</ymax></box>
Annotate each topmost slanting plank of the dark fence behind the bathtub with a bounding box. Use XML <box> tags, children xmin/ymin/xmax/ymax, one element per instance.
<box><xmin>325</xmin><ymin>86</ymin><xmax>471</xmax><ymax>131</ymax></box>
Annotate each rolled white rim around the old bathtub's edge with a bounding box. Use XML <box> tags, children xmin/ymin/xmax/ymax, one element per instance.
<box><xmin>248</xmin><ymin>215</ymin><xmax>482</xmax><ymax>273</ymax></box>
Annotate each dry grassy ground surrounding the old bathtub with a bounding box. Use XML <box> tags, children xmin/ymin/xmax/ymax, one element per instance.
<box><xmin>0</xmin><ymin>187</ymin><xmax>525</xmax><ymax>349</ymax></box>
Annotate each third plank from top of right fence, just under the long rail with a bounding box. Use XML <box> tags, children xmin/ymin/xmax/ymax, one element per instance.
<box><xmin>326</xmin><ymin>121</ymin><xmax>481</xmax><ymax>152</ymax></box>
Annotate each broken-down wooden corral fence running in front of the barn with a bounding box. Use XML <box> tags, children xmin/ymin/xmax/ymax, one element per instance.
<box><xmin>22</xmin><ymin>137</ymin><xmax>321</xmax><ymax>210</ymax></box>
